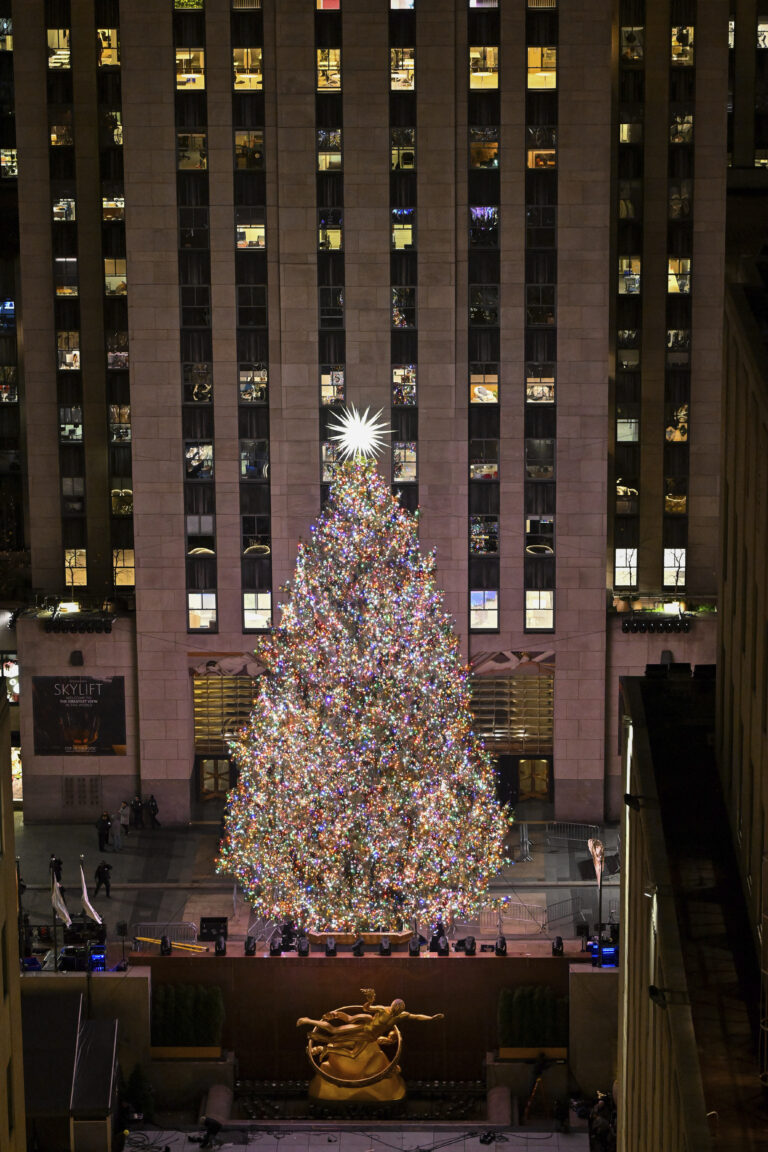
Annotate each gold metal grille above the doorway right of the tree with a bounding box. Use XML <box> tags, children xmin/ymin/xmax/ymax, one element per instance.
<box><xmin>472</xmin><ymin>669</ymin><xmax>554</xmax><ymax>756</ymax></box>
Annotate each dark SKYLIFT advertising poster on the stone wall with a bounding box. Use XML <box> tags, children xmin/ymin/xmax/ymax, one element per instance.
<box><xmin>32</xmin><ymin>676</ymin><xmax>126</xmax><ymax>756</ymax></box>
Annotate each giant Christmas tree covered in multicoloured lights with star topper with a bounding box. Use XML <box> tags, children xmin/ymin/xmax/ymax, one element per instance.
<box><xmin>218</xmin><ymin>410</ymin><xmax>509</xmax><ymax>931</ymax></box>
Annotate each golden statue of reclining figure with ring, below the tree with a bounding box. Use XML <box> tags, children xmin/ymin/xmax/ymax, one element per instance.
<box><xmin>296</xmin><ymin>988</ymin><xmax>443</xmax><ymax>1100</ymax></box>
